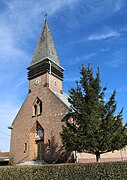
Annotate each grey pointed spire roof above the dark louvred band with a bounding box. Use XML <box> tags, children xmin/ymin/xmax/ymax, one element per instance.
<box><xmin>31</xmin><ymin>20</ymin><xmax>60</xmax><ymax>65</ymax></box>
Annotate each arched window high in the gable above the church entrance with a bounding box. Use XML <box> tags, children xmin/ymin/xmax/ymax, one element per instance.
<box><xmin>33</xmin><ymin>97</ymin><xmax>42</xmax><ymax>116</ymax></box>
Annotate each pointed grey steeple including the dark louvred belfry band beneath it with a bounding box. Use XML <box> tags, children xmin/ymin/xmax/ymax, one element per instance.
<box><xmin>27</xmin><ymin>20</ymin><xmax>64</xmax><ymax>80</ymax></box>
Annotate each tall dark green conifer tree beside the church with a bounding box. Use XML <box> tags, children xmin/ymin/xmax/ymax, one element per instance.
<box><xmin>61</xmin><ymin>65</ymin><xmax>127</xmax><ymax>162</ymax></box>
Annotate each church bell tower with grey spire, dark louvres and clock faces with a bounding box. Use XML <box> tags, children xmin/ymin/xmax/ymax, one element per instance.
<box><xmin>27</xmin><ymin>20</ymin><xmax>64</xmax><ymax>93</ymax></box>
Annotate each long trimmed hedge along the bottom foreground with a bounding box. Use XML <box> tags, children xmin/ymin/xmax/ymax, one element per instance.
<box><xmin>0</xmin><ymin>162</ymin><xmax>127</xmax><ymax>180</ymax></box>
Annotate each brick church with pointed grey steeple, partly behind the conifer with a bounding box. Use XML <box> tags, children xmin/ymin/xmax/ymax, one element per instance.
<box><xmin>10</xmin><ymin>20</ymin><xmax>127</xmax><ymax>163</ymax></box>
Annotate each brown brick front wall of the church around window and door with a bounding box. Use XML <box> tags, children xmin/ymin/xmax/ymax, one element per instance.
<box><xmin>10</xmin><ymin>74</ymin><xmax>68</xmax><ymax>163</ymax></box>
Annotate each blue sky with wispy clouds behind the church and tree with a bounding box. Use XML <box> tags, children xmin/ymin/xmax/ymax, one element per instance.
<box><xmin>0</xmin><ymin>0</ymin><xmax>127</xmax><ymax>151</ymax></box>
